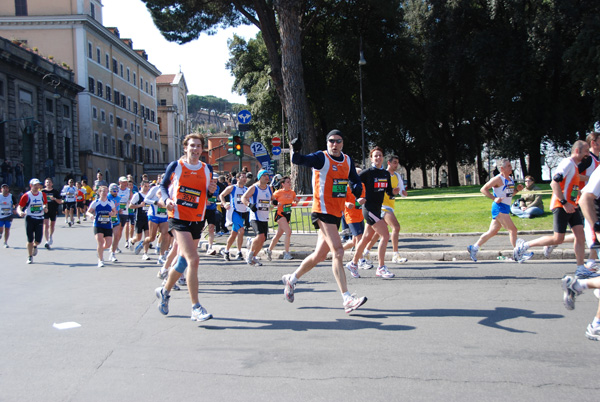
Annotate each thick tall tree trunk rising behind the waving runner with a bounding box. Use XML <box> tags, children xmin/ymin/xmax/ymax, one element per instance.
<box><xmin>274</xmin><ymin>0</ymin><xmax>317</xmax><ymax>194</ymax></box>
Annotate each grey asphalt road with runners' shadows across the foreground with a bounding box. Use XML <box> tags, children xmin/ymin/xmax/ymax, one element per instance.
<box><xmin>0</xmin><ymin>219</ymin><xmax>600</xmax><ymax>401</ymax></box>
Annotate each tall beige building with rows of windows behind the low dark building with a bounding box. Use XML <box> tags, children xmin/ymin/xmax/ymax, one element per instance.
<box><xmin>0</xmin><ymin>0</ymin><xmax>164</xmax><ymax>182</ymax></box>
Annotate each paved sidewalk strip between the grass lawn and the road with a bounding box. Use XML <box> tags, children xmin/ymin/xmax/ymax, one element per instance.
<box><xmin>206</xmin><ymin>231</ymin><xmax>575</xmax><ymax>262</ymax></box>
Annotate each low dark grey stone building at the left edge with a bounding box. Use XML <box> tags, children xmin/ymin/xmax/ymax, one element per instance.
<box><xmin>0</xmin><ymin>38</ymin><xmax>85</xmax><ymax>192</ymax></box>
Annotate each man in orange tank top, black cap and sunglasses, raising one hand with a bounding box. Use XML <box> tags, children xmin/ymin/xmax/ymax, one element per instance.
<box><xmin>281</xmin><ymin>130</ymin><xmax>367</xmax><ymax>313</ymax></box>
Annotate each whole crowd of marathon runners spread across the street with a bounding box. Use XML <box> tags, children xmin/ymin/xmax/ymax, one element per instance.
<box><xmin>0</xmin><ymin>130</ymin><xmax>600</xmax><ymax>340</ymax></box>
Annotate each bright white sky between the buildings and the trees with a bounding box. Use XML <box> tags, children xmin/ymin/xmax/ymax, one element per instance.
<box><xmin>102</xmin><ymin>0</ymin><xmax>258</xmax><ymax>104</ymax></box>
